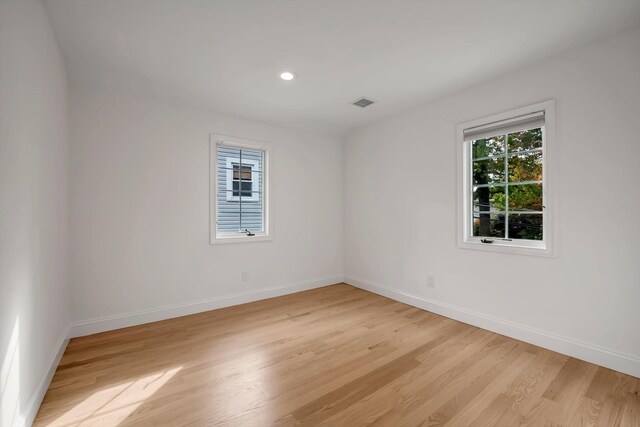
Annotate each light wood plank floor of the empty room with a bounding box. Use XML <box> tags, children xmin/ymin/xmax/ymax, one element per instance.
<box><xmin>35</xmin><ymin>285</ymin><xmax>640</xmax><ymax>427</ymax></box>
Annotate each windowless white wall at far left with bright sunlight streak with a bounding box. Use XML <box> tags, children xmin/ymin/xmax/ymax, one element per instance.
<box><xmin>0</xmin><ymin>0</ymin><xmax>69</xmax><ymax>426</ymax></box>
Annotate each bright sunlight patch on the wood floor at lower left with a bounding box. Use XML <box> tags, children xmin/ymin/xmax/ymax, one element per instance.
<box><xmin>47</xmin><ymin>367</ymin><xmax>182</xmax><ymax>427</ymax></box>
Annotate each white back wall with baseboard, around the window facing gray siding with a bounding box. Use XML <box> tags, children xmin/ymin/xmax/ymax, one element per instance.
<box><xmin>70</xmin><ymin>87</ymin><xmax>343</xmax><ymax>335</ymax></box>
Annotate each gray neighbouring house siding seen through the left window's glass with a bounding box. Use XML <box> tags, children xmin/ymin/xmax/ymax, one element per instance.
<box><xmin>216</xmin><ymin>145</ymin><xmax>264</xmax><ymax>233</ymax></box>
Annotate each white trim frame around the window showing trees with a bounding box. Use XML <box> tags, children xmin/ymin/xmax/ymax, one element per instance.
<box><xmin>456</xmin><ymin>99</ymin><xmax>557</xmax><ymax>256</ymax></box>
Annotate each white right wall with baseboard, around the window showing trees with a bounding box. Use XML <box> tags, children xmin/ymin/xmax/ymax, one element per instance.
<box><xmin>344</xmin><ymin>27</ymin><xmax>640</xmax><ymax>376</ymax></box>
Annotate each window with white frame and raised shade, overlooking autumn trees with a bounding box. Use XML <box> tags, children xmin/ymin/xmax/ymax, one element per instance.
<box><xmin>458</xmin><ymin>101</ymin><xmax>553</xmax><ymax>255</ymax></box>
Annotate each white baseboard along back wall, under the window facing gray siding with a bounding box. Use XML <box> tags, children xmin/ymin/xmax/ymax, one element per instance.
<box><xmin>69</xmin><ymin>276</ymin><xmax>342</xmax><ymax>338</ymax></box>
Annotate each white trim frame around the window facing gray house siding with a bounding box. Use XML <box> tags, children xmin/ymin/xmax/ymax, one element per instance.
<box><xmin>209</xmin><ymin>134</ymin><xmax>274</xmax><ymax>245</ymax></box>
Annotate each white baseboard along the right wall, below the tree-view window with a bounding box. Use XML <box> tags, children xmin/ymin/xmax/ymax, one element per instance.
<box><xmin>344</xmin><ymin>277</ymin><xmax>640</xmax><ymax>378</ymax></box>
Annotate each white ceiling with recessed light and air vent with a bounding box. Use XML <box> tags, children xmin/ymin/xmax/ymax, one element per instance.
<box><xmin>45</xmin><ymin>0</ymin><xmax>640</xmax><ymax>136</ymax></box>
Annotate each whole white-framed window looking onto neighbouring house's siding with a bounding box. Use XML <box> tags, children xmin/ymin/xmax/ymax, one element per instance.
<box><xmin>211</xmin><ymin>135</ymin><xmax>270</xmax><ymax>243</ymax></box>
